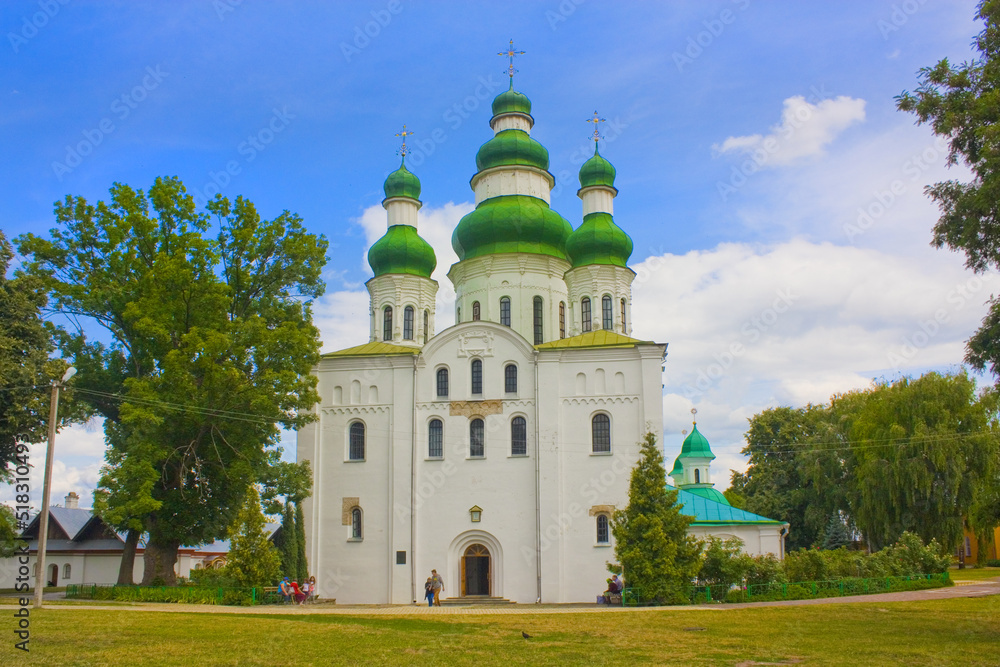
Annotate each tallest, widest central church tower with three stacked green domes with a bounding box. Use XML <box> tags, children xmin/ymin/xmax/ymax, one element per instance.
<box><xmin>448</xmin><ymin>42</ymin><xmax>573</xmax><ymax>345</ymax></box>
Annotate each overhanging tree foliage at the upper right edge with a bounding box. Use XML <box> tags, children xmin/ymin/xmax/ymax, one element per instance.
<box><xmin>896</xmin><ymin>0</ymin><xmax>1000</xmax><ymax>379</ymax></box>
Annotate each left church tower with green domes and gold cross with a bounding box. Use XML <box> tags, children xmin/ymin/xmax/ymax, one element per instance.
<box><xmin>365</xmin><ymin>125</ymin><xmax>438</xmax><ymax>347</ymax></box>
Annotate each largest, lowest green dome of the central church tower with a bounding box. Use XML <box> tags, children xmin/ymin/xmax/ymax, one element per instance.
<box><xmin>451</xmin><ymin>195</ymin><xmax>573</xmax><ymax>260</ymax></box>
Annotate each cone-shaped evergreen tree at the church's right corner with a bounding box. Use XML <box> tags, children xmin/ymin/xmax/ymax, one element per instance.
<box><xmin>608</xmin><ymin>433</ymin><xmax>701</xmax><ymax>604</ymax></box>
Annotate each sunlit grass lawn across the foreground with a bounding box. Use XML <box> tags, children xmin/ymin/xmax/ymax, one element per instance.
<box><xmin>0</xmin><ymin>597</ymin><xmax>1000</xmax><ymax>666</ymax></box>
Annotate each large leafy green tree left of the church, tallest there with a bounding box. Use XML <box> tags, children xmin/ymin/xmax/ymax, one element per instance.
<box><xmin>19</xmin><ymin>178</ymin><xmax>326</xmax><ymax>583</ymax></box>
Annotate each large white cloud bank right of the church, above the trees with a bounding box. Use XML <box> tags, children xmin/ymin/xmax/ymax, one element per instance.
<box><xmin>632</xmin><ymin>239</ymin><xmax>988</xmax><ymax>489</ymax></box>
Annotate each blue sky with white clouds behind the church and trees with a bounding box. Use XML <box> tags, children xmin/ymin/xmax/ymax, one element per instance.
<box><xmin>0</xmin><ymin>0</ymin><xmax>993</xmax><ymax>505</ymax></box>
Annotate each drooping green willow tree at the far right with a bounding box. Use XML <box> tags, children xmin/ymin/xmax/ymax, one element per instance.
<box><xmin>831</xmin><ymin>373</ymin><xmax>1000</xmax><ymax>549</ymax></box>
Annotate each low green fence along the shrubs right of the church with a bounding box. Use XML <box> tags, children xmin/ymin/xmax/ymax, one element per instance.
<box><xmin>622</xmin><ymin>572</ymin><xmax>950</xmax><ymax>607</ymax></box>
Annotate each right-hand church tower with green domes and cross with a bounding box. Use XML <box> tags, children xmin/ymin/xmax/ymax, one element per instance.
<box><xmin>566</xmin><ymin>111</ymin><xmax>635</xmax><ymax>336</ymax></box>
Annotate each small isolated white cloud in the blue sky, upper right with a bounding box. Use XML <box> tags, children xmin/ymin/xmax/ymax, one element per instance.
<box><xmin>712</xmin><ymin>95</ymin><xmax>865</xmax><ymax>168</ymax></box>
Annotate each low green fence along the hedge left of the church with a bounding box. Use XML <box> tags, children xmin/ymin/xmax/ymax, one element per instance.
<box><xmin>66</xmin><ymin>584</ymin><xmax>282</xmax><ymax>606</ymax></box>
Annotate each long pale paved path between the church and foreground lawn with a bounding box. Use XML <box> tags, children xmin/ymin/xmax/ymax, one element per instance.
<box><xmin>21</xmin><ymin>581</ymin><xmax>1000</xmax><ymax>616</ymax></box>
